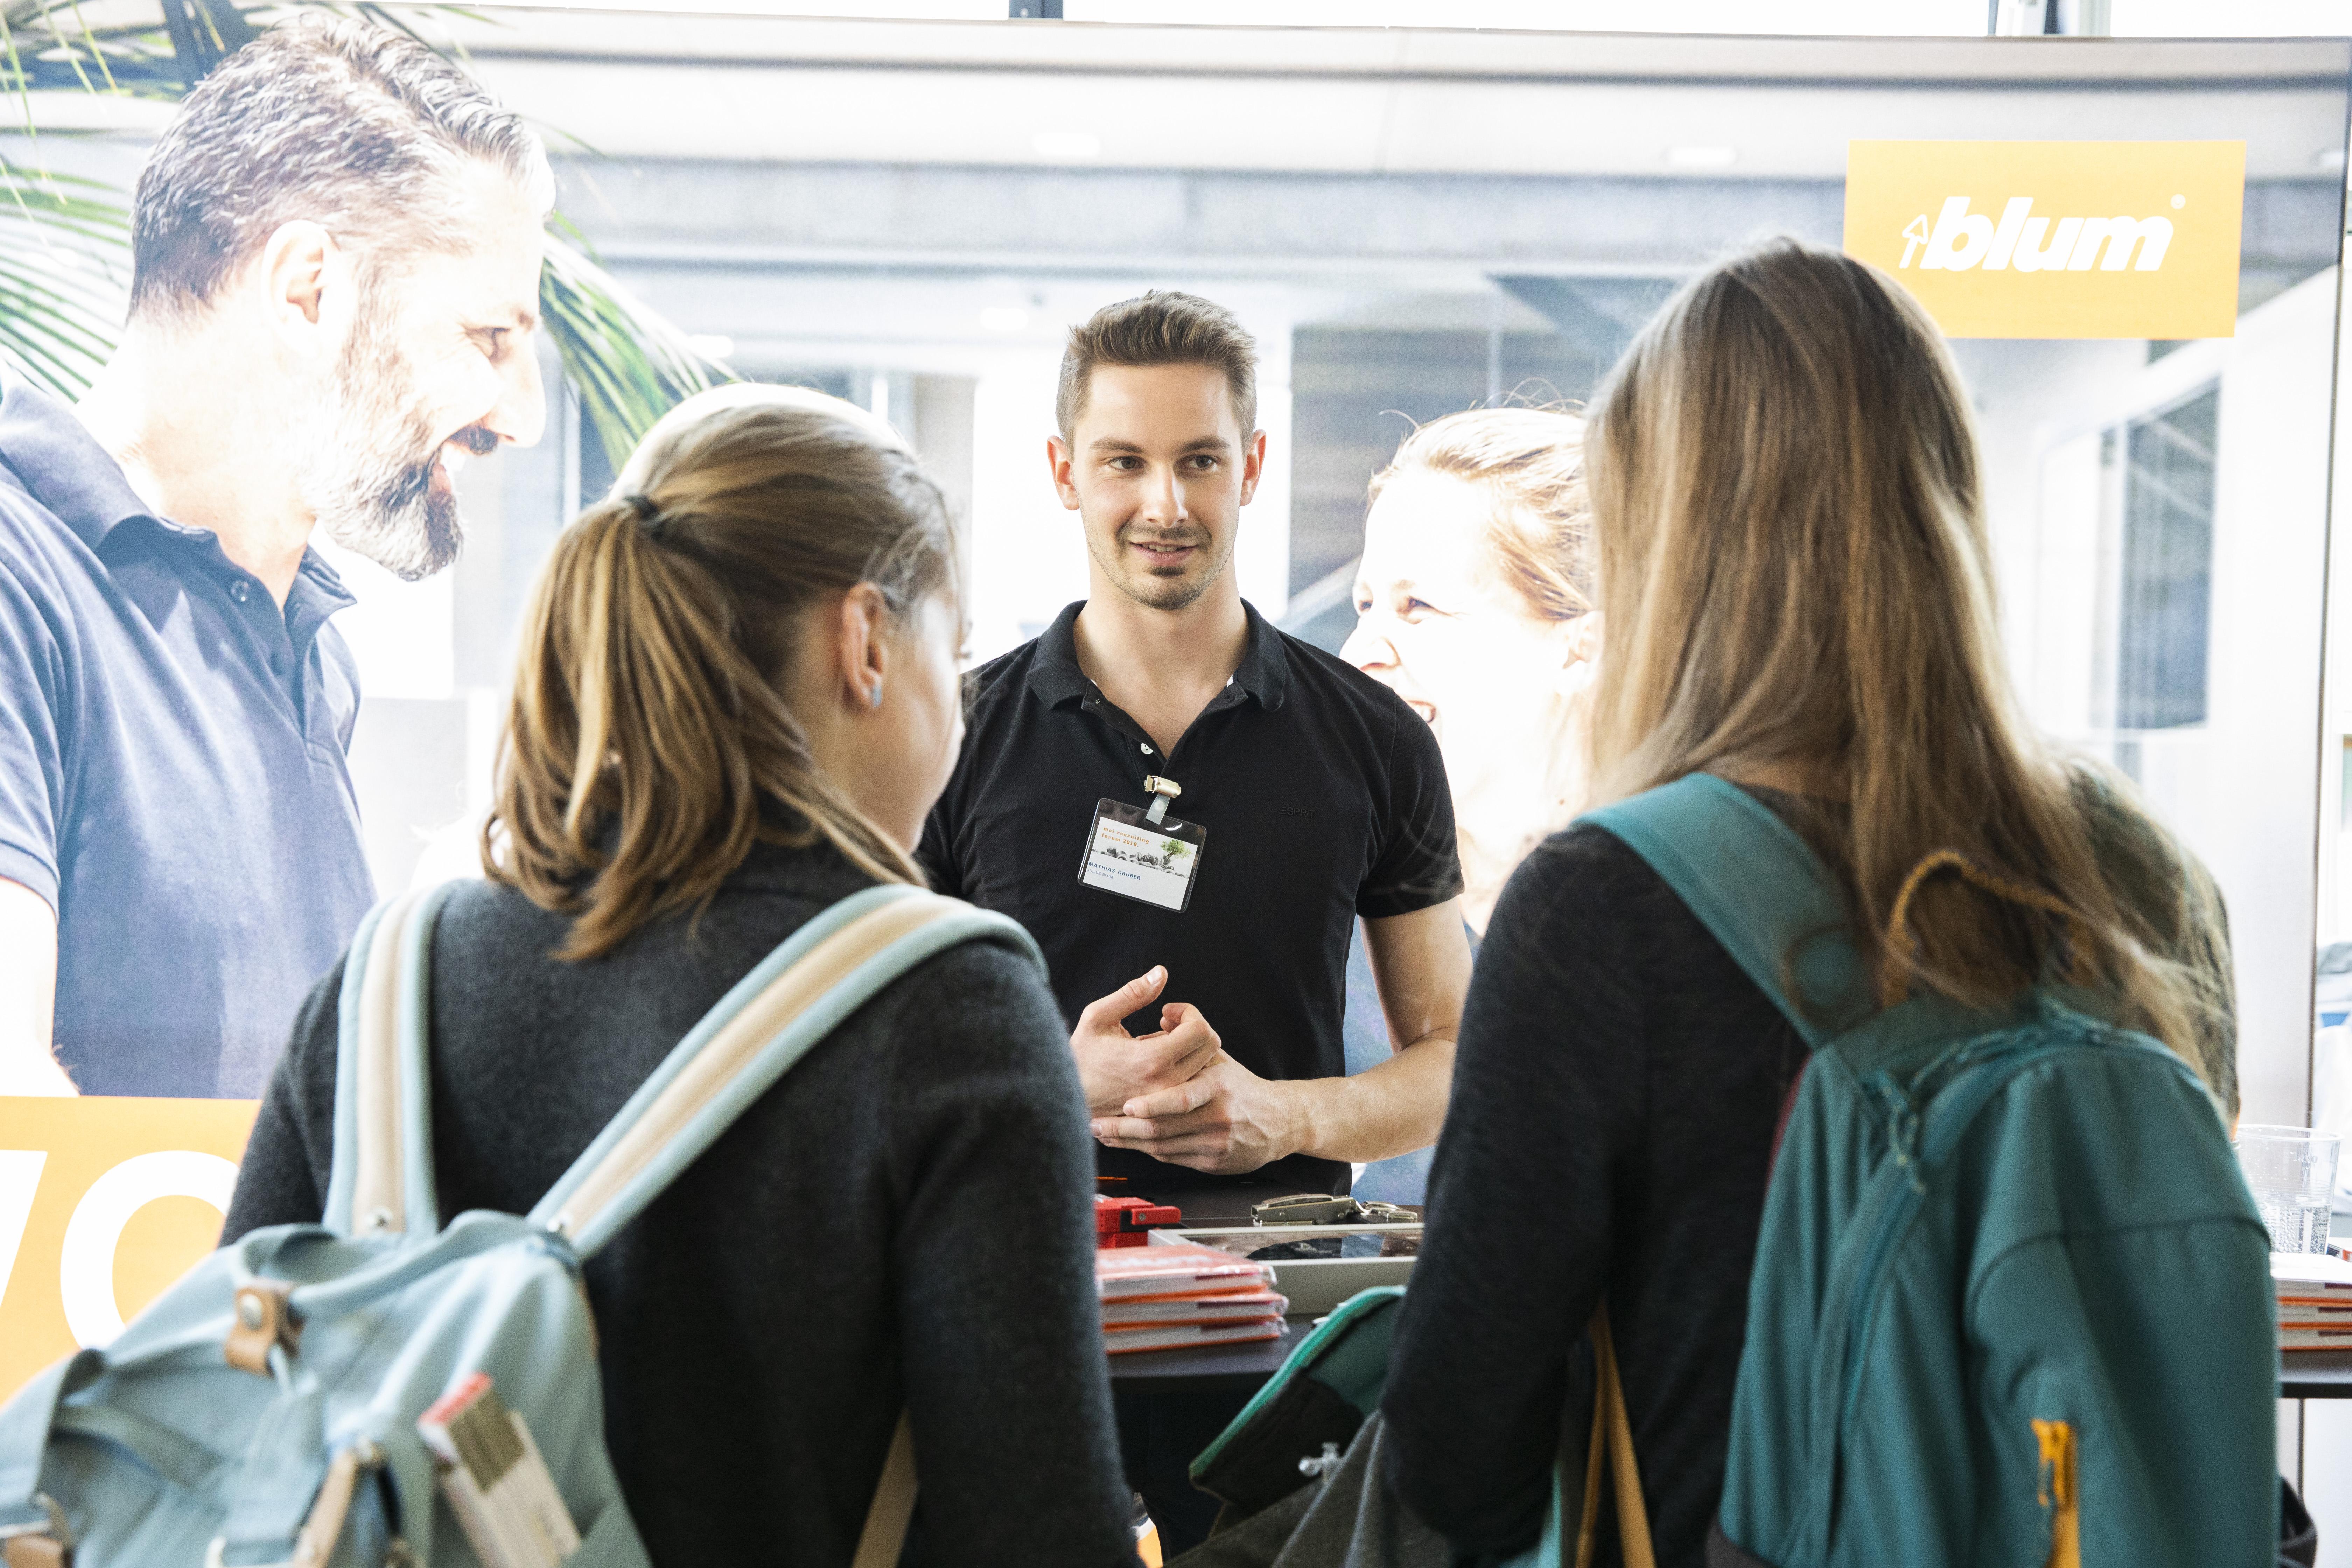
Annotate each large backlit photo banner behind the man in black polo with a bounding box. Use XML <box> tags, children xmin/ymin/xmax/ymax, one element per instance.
<box><xmin>0</xmin><ymin>0</ymin><xmax>2352</xmax><ymax>1396</ymax></box>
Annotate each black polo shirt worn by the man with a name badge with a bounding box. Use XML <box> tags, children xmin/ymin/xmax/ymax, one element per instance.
<box><xmin>922</xmin><ymin>604</ymin><xmax>1463</xmax><ymax>1192</ymax></box>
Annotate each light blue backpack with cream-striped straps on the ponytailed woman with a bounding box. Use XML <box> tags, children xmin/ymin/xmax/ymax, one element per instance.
<box><xmin>0</xmin><ymin>886</ymin><xmax>1044</xmax><ymax>1568</ymax></box>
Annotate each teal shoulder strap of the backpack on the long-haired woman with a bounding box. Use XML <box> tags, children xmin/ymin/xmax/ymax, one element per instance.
<box><xmin>1581</xmin><ymin>774</ymin><xmax>1879</xmax><ymax>1049</ymax></box>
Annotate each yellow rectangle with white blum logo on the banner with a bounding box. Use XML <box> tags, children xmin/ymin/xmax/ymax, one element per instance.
<box><xmin>1846</xmin><ymin>141</ymin><xmax>2246</xmax><ymax>338</ymax></box>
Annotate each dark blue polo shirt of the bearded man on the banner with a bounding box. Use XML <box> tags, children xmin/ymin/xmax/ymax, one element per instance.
<box><xmin>0</xmin><ymin>381</ymin><xmax>374</xmax><ymax>1098</ymax></box>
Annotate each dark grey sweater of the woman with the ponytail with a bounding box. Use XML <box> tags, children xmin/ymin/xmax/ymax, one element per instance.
<box><xmin>226</xmin><ymin>849</ymin><xmax>1134</xmax><ymax>1568</ymax></box>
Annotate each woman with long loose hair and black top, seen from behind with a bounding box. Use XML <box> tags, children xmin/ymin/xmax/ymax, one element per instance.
<box><xmin>1383</xmin><ymin>242</ymin><xmax>2237</xmax><ymax>1568</ymax></box>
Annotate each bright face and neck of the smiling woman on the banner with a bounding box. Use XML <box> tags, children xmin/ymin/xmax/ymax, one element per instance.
<box><xmin>1340</xmin><ymin>472</ymin><xmax>1592</xmax><ymax>929</ymax></box>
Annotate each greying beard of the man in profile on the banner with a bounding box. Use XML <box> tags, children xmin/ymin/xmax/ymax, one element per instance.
<box><xmin>303</xmin><ymin>288</ymin><xmax>479</xmax><ymax>583</ymax></box>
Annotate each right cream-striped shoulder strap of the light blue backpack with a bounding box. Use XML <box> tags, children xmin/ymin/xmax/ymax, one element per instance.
<box><xmin>529</xmin><ymin>884</ymin><xmax>1044</xmax><ymax>1258</ymax></box>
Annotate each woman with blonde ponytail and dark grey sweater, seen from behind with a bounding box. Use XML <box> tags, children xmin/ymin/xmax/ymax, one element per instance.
<box><xmin>226</xmin><ymin>388</ymin><xmax>1131</xmax><ymax>1568</ymax></box>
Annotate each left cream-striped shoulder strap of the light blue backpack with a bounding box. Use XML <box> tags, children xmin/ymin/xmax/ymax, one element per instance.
<box><xmin>322</xmin><ymin>882</ymin><xmax>456</xmax><ymax>1237</ymax></box>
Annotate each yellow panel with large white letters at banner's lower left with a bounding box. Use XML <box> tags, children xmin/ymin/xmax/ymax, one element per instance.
<box><xmin>0</xmin><ymin>1096</ymin><xmax>261</xmax><ymax>1399</ymax></box>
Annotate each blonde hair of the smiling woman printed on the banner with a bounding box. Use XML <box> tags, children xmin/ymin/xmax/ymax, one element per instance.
<box><xmin>1369</xmin><ymin>407</ymin><xmax>1592</xmax><ymax>621</ymax></box>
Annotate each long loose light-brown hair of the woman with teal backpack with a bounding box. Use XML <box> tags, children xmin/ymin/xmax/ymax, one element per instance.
<box><xmin>1585</xmin><ymin>242</ymin><xmax>2237</xmax><ymax>1107</ymax></box>
